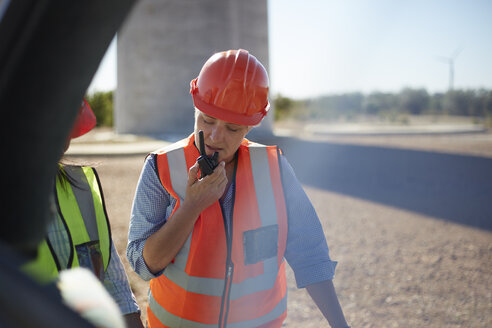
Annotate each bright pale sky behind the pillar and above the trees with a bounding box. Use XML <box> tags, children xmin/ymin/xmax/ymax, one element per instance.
<box><xmin>89</xmin><ymin>0</ymin><xmax>492</xmax><ymax>99</ymax></box>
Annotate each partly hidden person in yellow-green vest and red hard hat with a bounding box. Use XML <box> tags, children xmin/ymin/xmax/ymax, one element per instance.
<box><xmin>24</xmin><ymin>99</ymin><xmax>143</xmax><ymax>328</ymax></box>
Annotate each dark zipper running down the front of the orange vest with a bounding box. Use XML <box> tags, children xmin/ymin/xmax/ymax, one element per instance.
<box><xmin>218</xmin><ymin>152</ymin><xmax>238</xmax><ymax>328</ymax></box>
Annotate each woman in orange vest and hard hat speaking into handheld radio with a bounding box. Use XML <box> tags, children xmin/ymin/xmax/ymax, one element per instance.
<box><xmin>127</xmin><ymin>49</ymin><xmax>347</xmax><ymax>328</ymax></box>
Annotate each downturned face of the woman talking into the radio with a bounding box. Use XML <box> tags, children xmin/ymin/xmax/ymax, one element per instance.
<box><xmin>195</xmin><ymin>110</ymin><xmax>251</xmax><ymax>164</ymax></box>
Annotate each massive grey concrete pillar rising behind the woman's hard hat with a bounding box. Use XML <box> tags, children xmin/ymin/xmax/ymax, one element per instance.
<box><xmin>115</xmin><ymin>0</ymin><xmax>273</xmax><ymax>136</ymax></box>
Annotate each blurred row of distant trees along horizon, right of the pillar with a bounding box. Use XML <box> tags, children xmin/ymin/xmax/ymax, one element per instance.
<box><xmin>274</xmin><ymin>88</ymin><xmax>492</xmax><ymax>122</ymax></box>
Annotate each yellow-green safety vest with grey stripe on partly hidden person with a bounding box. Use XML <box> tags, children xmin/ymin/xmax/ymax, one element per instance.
<box><xmin>26</xmin><ymin>166</ymin><xmax>111</xmax><ymax>282</ymax></box>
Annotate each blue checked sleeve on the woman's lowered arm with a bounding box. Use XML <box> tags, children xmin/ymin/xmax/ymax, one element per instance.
<box><xmin>280</xmin><ymin>156</ymin><xmax>337</xmax><ymax>288</ymax></box>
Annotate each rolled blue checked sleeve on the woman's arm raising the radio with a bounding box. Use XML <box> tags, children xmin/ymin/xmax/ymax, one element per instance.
<box><xmin>126</xmin><ymin>155</ymin><xmax>176</xmax><ymax>281</ymax></box>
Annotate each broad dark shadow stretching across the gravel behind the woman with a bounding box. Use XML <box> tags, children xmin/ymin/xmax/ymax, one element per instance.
<box><xmin>262</xmin><ymin>137</ymin><xmax>492</xmax><ymax>230</ymax></box>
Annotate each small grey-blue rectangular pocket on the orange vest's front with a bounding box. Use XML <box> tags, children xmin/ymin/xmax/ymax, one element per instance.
<box><xmin>243</xmin><ymin>224</ymin><xmax>278</xmax><ymax>265</ymax></box>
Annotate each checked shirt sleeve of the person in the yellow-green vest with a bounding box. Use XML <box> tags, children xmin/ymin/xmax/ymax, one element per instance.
<box><xmin>103</xmin><ymin>245</ymin><xmax>140</xmax><ymax>315</ymax></box>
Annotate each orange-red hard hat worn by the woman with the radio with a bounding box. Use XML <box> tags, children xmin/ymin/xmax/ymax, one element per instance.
<box><xmin>190</xmin><ymin>49</ymin><xmax>270</xmax><ymax>125</ymax></box>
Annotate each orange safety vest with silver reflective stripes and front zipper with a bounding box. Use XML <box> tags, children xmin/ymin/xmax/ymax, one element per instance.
<box><xmin>147</xmin><ymin>135</ymin><xmax>288</xmax><ymax>328</ymax></box>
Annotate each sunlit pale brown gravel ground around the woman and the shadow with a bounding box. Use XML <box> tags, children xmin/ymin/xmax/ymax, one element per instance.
<box><xmin>66</xmin><ymin>129</ymin><xmax>492</xmax><ymax>328</ymax></box>
